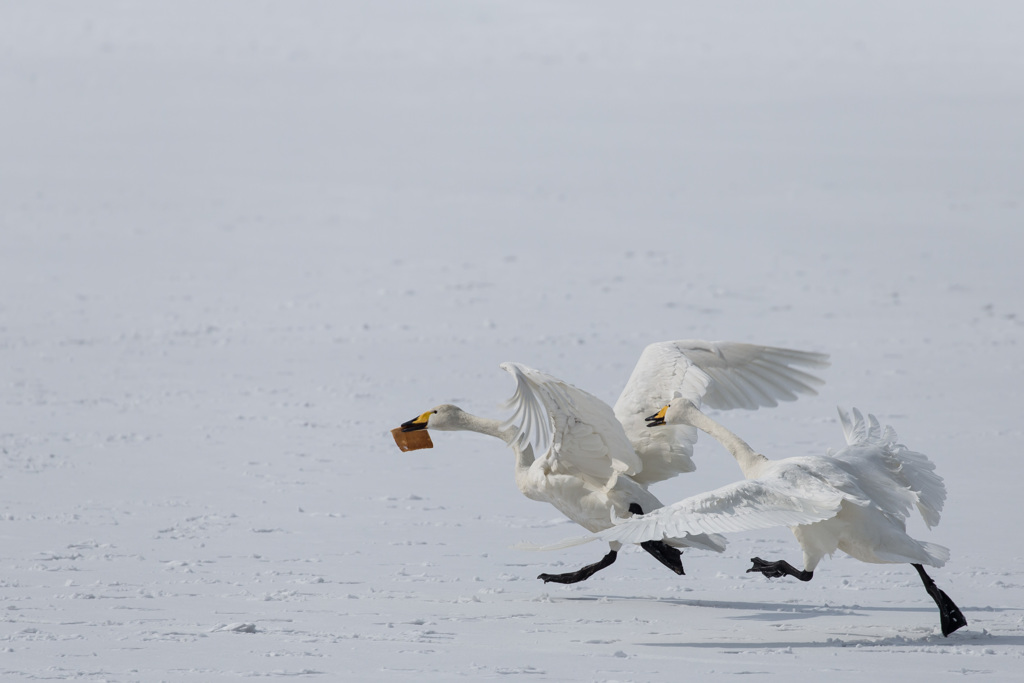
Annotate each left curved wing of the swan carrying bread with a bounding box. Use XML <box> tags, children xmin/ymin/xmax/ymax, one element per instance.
<box><xmin>501</xmin><ymin>362</ymin><xmax>643</xmax><ymax>487</ymax></box>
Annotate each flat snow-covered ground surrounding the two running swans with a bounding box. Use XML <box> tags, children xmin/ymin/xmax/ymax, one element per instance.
<box><xmin>0</xmin><ymin>0</ymin><xmax>1024</xmax><ymax>682</ymax></box>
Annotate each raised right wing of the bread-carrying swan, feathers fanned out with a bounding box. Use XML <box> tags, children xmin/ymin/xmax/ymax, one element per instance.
<box><xmin>614</xmin><ymin>339</ymin><xmax>828</xmax><ymax>484</ymax></box>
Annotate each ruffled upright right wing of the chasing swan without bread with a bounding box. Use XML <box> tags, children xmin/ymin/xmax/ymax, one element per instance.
<box><xmin>829</xmin><ymin>409</ymin><xmax>946</xmax><ymax>528</ymax></box>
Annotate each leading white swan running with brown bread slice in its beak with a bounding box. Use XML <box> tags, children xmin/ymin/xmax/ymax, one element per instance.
<box><xmin>401</xmin><ymin>340</ymin><xmax>828</xmax><ymax>584</ymax></box>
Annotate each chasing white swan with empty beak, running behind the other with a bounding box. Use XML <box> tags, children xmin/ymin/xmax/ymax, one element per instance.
<box><xmin>589</xmin><ymin>398</ymin><xmax>967</xmax><ymax>636</ymax></box>
